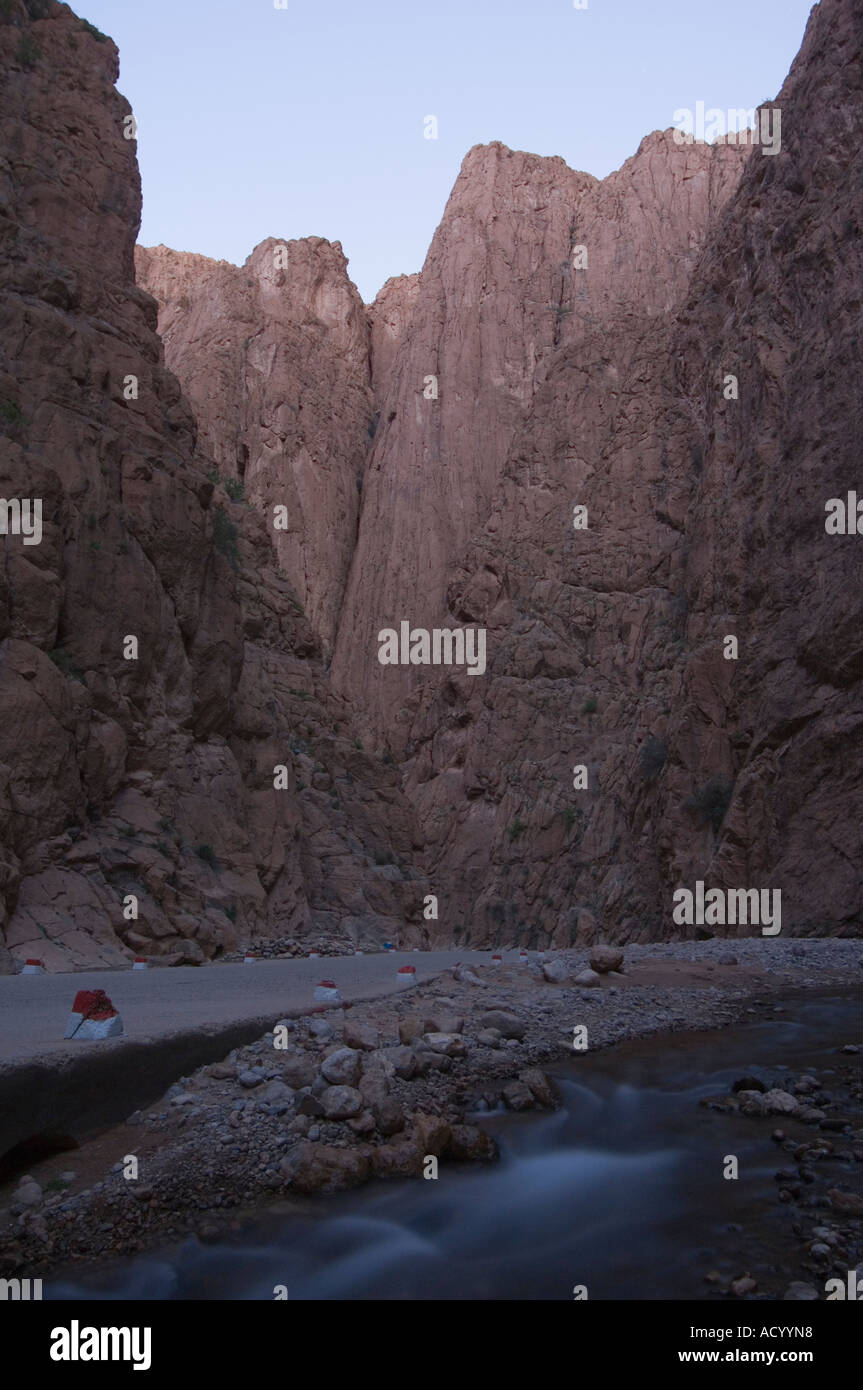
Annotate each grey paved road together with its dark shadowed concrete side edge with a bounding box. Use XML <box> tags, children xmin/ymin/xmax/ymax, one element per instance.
<box><xmin>0</xmin><ymin>951</ymin><xmax>516</xmax><ymax>1158</ymax></box>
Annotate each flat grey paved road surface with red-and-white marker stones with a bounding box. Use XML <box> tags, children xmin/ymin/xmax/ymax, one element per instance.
<box><xmin>0</xmin><ymin>951</ymin><xmax>497</xmax><ymax>1063</ymax></box>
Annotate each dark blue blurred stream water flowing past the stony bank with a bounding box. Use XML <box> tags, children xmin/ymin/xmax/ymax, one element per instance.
<box><xmin>46</xmin><ymin>997</ymin><xmax>863</xmax><ymax>1300</ymax></box>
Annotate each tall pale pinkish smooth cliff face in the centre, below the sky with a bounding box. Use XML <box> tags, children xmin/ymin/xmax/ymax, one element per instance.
<box><xmin>326</xmin><ymin>132</ymin><xmax>743</xmax><ymax>752</ymax></box>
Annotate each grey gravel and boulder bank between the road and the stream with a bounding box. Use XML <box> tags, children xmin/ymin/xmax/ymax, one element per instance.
<box><xmin>0</xmin><ymin>938</ymin><xmax>863</xmax><ymax>1297</ymax></box>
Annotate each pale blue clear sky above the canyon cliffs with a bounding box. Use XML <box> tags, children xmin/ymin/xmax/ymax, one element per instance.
<box><xmin>80</xmin><ymin>0</ymin><xmax>812</xmax><ymax>300</ymax></box>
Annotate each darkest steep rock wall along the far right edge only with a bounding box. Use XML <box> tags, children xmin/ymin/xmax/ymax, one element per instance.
<box><xmin>659</xmin><ymin>0</ymin><xmax>863</xmax><ymax>934</ymax></box>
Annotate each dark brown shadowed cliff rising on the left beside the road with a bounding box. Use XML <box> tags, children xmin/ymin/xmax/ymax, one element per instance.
<box><xmin>0</xmin><ymin>0</ymin><xmax>425</xmax><ymax>969</ymax></box>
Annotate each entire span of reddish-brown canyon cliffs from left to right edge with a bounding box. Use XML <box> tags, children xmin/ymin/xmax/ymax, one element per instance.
<box><xmin>0</xmin><ymin>0</ymin><xmax>863</xmax><ymax>962</ymax></box>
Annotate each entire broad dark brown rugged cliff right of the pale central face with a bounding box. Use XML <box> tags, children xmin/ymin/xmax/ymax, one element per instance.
<box><xmin>407</xmin><ymin>0</ymin><xmax>863</xmax><ymax>945</ymax></box>
